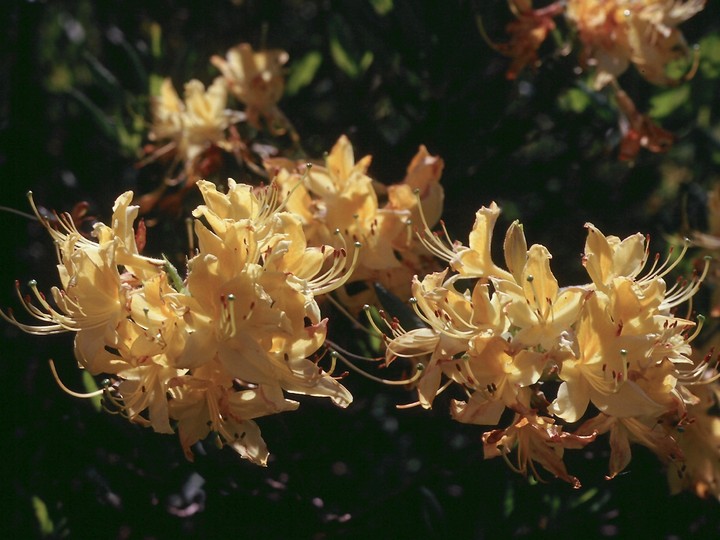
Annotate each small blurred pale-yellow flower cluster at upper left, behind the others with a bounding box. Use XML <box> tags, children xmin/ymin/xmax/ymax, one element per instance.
<box><xmin>138</xmin><ymin>43</ymin><xmax>299</xmax><ymax>214</ymax></box>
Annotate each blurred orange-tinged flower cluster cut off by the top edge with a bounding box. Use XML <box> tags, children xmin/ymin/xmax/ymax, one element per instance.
<box><xmin>488</xmin><ymin>0</ymin><xmax>705</xmax><ymax>160</ymax></box>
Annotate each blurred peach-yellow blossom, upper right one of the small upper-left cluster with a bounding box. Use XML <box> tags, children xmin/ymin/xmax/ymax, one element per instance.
<box><xmin>210</xmin><ymin>43</ymin><xmax>288</xmax><ymax>127</ymax></box>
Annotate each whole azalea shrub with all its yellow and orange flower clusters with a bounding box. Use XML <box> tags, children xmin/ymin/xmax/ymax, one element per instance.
<box><xmin>0</xmin><ymin>0</ymin><xmax>720</xmax><ymax>536</ymax></box>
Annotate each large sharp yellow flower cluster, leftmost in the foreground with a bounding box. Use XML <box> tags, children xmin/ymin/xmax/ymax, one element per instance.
<box><xmin>2</xmin><ymin>180</ymin><xmax>359</xmax><ymax>465</ymax></box>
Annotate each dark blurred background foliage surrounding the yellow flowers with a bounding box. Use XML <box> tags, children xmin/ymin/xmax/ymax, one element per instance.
<box><xmin>0</xmin><ymin>0</ymin><xmax>720</xmax><ymax>538</ymax></box>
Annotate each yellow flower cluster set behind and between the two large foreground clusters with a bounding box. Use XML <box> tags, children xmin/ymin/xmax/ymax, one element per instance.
<box><xmin>265</xmin><ymin>135</ymin><xmax>444</xmax><ymax>311</ymax></box>
